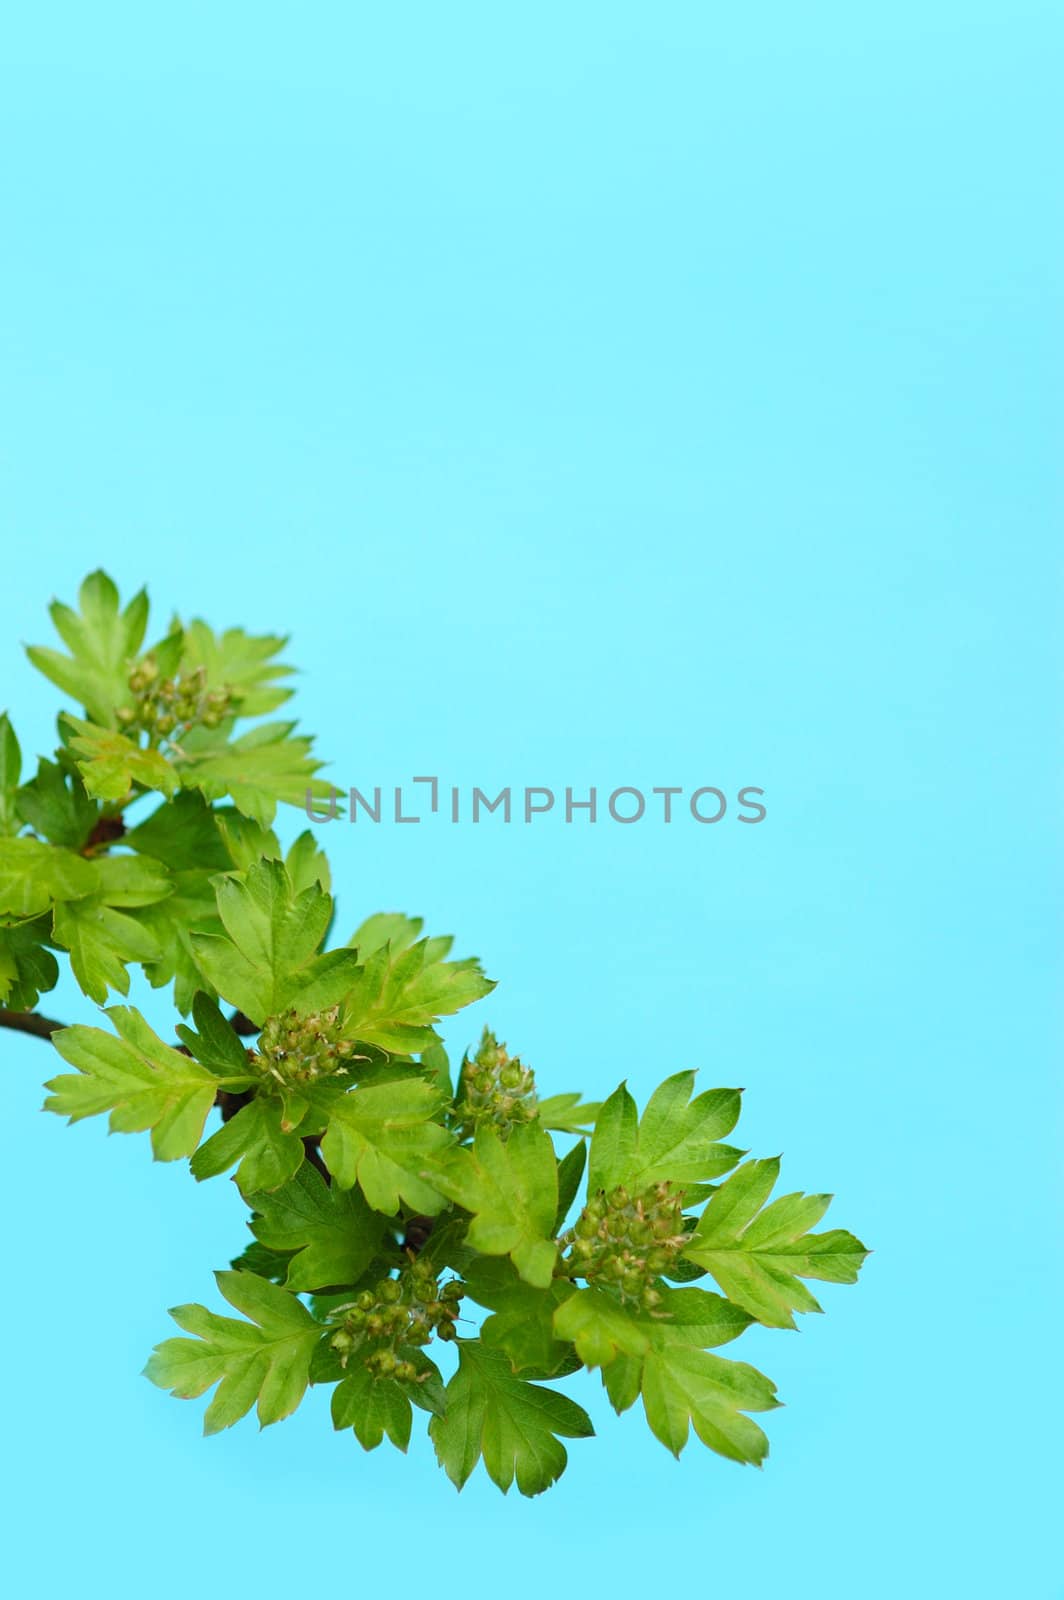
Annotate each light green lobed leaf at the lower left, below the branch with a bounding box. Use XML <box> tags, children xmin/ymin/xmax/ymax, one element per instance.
<box><xmin>144</xmin><ymin>1272</ymin><xmax>322</xmax><ymax>1434</ymax></box>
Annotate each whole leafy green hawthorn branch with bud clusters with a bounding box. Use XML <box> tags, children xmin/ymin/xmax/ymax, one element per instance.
<box><xmin>0</xmin><ymin>573</ymin><xmax>866</xmax><ymax>1494</ymax></box>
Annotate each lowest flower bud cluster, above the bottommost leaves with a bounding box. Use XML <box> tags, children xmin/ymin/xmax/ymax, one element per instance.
<box><xmin>330</xmin><ymin>1261</ymin><xmax>464</xmax><ymax>1384</ymax></box>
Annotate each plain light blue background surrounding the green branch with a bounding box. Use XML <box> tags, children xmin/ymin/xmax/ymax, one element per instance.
<box><xmin>0</xmin><ymin>0</ymin><xmax>1062</xmax><ymax>1600</ymax></box>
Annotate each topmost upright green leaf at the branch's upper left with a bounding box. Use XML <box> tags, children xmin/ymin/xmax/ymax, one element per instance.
<box><xmin>26</xmin><ymin>571</ymin><xmax>147</xmax><ymax>726</ymax></box>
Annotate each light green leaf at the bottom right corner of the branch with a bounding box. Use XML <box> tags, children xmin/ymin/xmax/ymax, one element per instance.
<box><xmin>633</xmin><ymin>1344</ymin><xmax>779</xmax><ymax>1467</ymax></box>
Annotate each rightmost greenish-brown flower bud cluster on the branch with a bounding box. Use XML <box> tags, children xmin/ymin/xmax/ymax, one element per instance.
<box><xmin>562</xmin><ymin>1184</ymin><xmax>686</xmax><ymax>1312</ymax></box>
